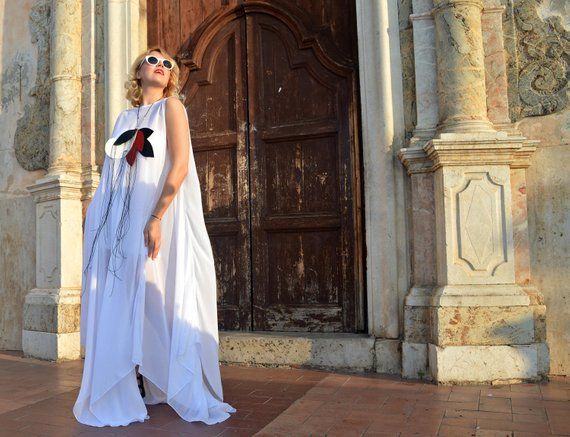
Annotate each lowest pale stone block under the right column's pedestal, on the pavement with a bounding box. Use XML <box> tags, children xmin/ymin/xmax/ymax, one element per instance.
<box><xmin>428</xmin><ymin>343</ymin><xmax>549</xmax><ymax>384</ymax></box>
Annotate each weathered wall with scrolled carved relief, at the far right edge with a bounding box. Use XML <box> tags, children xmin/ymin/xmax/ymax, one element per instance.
<box><xmin>504</xmin><ymin>0</ymin><xmax>570</xmax><ymax>375</ymax></box>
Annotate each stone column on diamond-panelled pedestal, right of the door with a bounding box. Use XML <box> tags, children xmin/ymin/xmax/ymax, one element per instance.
<box><xmin>424</xmin><ymin>0</ymin><xmax>542</xmax><ymax>383</ymax></box>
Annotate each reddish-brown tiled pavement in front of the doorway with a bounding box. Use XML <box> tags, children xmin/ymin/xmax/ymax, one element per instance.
<box><xmin>0</xmin><ymin>351</ymin><xmax>570</xmax><ymax>437</ymax></box>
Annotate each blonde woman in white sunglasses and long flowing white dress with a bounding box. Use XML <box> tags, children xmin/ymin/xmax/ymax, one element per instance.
<box><xmin>73</xmin><ymin>47</ymin><xmax>236</xmax><ymax>427</ymax></box>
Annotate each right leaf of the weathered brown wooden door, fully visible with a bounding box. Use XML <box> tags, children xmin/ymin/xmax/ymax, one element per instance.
<box><xmin>246</xmin><ymin>13</ymin><xmax>355</xmax><ymax>331</ymax></box>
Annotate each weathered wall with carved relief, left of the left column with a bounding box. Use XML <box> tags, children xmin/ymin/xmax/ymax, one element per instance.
<box><xmin>0</xmin><ymin>0</ymin><xmax>51</xmax><ymax>350</ymax></box>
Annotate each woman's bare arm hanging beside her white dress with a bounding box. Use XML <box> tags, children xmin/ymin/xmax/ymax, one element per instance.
<box><xmin>144</xmin><ymin>97</ymin><xmax>190</xmax><ymax>259</ymax></box>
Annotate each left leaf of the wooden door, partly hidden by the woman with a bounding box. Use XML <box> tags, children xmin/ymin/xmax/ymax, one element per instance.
<box><xmin>182</xmin><ymin>20</ymin><xmax>251</xmax><ymax>330</ymax></box>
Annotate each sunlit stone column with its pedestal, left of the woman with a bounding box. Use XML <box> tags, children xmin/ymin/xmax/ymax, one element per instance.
<box><xmin>22</xmin><ymin>0</ymin><xmax>82</xmax><ymax>360</ymax></box>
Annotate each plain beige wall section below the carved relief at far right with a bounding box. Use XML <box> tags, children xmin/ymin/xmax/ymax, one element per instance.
<box><xmin>519</xmin><ymin>126</ymin><xmax>570</xmax><ymax>375</ymax></box>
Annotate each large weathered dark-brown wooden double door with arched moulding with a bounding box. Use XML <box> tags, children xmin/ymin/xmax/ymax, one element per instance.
<box><xmin>148</xmin><ymin>0</ymin><xmax>364</xmax><ymax>332</ymax></box>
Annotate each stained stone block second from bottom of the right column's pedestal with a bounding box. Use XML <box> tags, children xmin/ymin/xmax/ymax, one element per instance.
<box><xmin>431</xmin><ymin>306</ymin><xmax>534</xmax><ymax>346</ymax></box>
